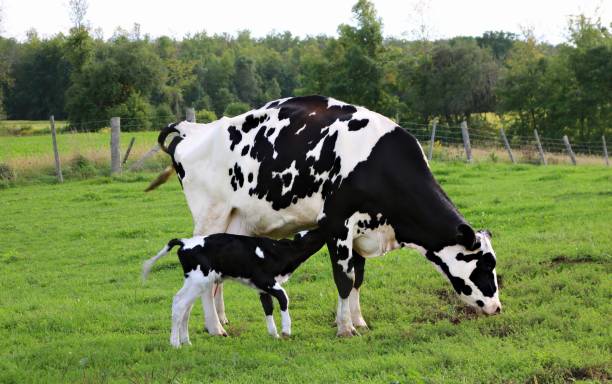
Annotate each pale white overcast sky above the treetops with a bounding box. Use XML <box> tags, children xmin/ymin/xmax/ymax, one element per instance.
<box><xmin>0</xmin><ymin>0</ymin><xmax>612</xmax><ymax>43</ymax></box>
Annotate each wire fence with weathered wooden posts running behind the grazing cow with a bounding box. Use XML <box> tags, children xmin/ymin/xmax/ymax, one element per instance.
<box><xmin>0</xmin><ymin>110</ymin><xmax>609</xmax><ymax>184</ymax></box>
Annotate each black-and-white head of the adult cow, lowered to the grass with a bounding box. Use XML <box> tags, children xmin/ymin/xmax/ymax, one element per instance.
<box><xmin>427</xmin><ymin>224</ymin><xmax>501</xmax><ymax>315</ymax></box>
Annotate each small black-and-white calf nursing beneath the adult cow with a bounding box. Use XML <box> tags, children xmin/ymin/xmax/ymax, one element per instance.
<box><xmin>142</xmin><ymin>230</ymin><xmax>325</xmax><ymax>347</ymax></box>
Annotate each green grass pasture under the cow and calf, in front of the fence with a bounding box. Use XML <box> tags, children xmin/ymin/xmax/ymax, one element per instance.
<box><xmin>0</xmin><ymin>163</ymin><xmax>612</xmax><ymax>383</ymax></box>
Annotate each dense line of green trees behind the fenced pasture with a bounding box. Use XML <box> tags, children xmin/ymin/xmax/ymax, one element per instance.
<box><xmin>0</xmin><ymin>0</ymin><xmax>612</xmax><ymax>140</ymax></box>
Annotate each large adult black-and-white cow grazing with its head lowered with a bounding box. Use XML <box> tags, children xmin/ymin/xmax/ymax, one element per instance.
<box><xmin>153</xmin><ymin>96</ymin><xmax>501</xmax><ymax>336</ymax></box>
